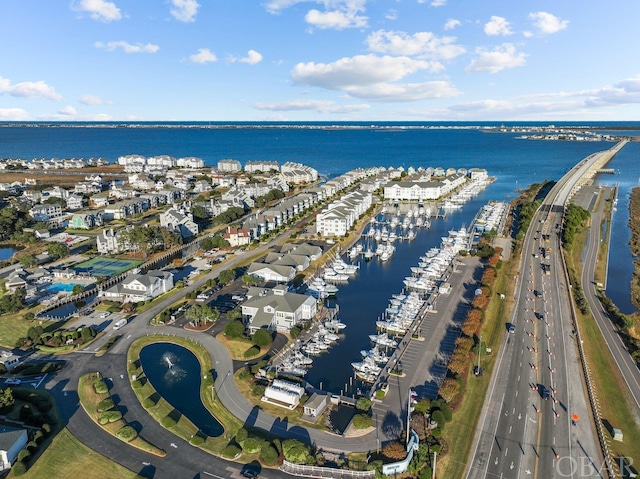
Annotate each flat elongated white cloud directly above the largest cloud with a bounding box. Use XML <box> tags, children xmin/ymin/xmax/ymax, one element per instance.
<box><xmin>367</xmin><ymin>30</ymin><xmax>465</xmax><ymax>60</ymax></box>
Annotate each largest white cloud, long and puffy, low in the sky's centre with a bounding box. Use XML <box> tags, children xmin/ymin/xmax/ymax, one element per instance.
<box><xmin>291</xmin><ymin>55</ymin><xmax>459</xmax><ymax>101</ymax></box>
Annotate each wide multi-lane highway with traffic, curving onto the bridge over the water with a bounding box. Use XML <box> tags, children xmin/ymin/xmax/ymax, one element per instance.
<box><xmin>466</xmin><ymin>143</ymin><xmax>624</xmax><ymax>479</ymax></box>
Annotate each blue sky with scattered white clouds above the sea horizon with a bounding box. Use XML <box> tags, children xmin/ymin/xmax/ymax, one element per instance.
<box><xmin>0</xmin><ymin>0</ymin><xmax>640</xmax><ymax>121</ymax></box>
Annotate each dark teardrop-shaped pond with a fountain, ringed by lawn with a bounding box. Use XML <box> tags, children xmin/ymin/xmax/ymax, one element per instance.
<box><xmin>140</xmin><ymin>343</ymin><xmax>224</xmax><ymax>437</ymax></box>
